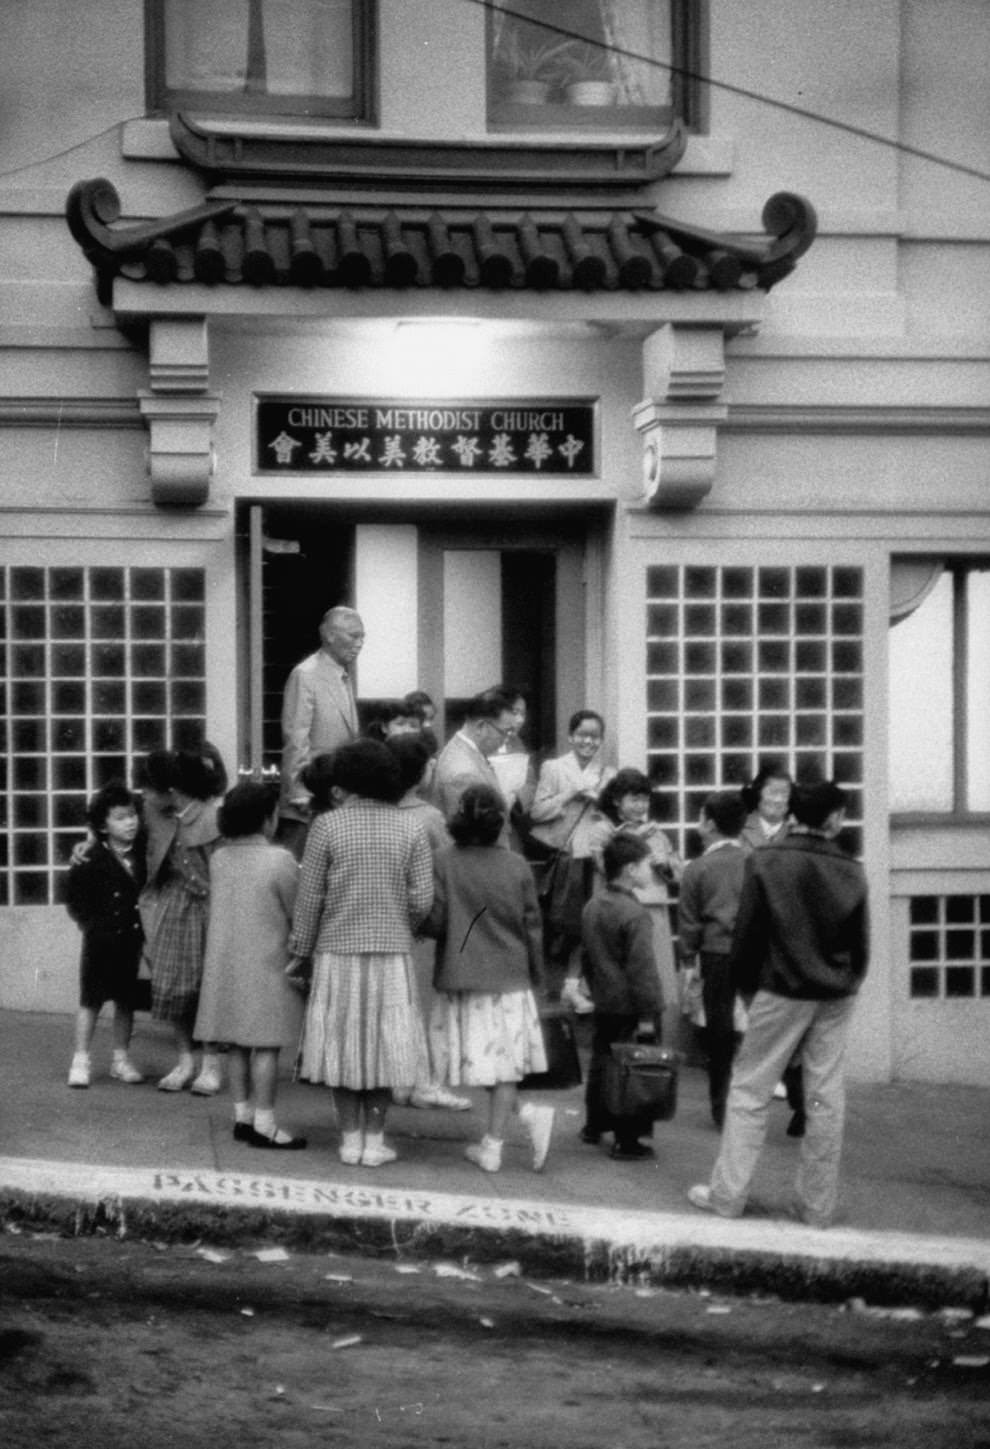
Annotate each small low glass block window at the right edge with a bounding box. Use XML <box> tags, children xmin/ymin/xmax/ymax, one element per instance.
<box><xmin>907</xmin><ymin>895</ymin><xmax>990</xmax><ymax>1001</ymax></box>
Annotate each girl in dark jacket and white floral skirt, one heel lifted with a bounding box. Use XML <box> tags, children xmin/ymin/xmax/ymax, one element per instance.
<box><xmin>428</xmin><ymin>785</ymin><xmax>554</xmax><ymax>1172</ymax></box>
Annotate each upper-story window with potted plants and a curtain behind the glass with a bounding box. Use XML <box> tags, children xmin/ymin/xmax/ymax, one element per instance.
<box><xmin>487</xmin><ymin>0</ymin><xmax>702</xmax><ymax>130</ymax></box>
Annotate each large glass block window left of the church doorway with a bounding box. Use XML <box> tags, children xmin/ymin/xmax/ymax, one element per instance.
<box><xmin>0</xmin><ymin>565</ymin><xmax>206</xmax><ymax>906</ymax></box>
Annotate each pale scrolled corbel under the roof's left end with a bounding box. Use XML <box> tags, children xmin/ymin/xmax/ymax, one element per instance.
<box><xmin>138</xmin><ymin>317</ymin><xmax>220</xmax><ymax>509</ymax></box>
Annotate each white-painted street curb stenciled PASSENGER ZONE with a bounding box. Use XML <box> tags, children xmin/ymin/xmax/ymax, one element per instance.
<box><xmin>0</xmin><ymin>1158</ymin><xmax>990</xmax><ymax>1313</ymax></box>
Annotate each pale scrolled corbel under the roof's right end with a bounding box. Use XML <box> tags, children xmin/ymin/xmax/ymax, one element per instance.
<box><xmin>632</xmin><ymin>325</ymin><xmax>728</xmax><ymax>510</ymax></box>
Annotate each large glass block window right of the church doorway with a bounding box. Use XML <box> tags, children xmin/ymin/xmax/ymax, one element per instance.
<box><xmin>646</xmin><ymin>564</ymin><xmax>864</xmax><ymax>853</ymax></box>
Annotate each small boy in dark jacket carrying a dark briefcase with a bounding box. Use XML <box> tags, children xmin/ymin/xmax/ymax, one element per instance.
<box><xmin>581</xmin><ymin>835</ymin><xmax>664</xmax><ymax>1161</ymax></box>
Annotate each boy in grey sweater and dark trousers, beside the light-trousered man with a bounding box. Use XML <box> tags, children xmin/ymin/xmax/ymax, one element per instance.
<box><xmin>677</xmin><ymin>790</ymin><xmax>746</xmax><ymax>1127</ymax></box>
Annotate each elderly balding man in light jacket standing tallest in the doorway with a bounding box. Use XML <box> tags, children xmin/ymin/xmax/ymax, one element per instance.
<box><xmin>278</xmin><ymin>604</ymin><xmax>364</xmax><ymax>859</ymax></box>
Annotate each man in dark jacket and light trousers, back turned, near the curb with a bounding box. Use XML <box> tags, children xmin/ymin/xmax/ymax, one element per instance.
<box><xmin>689</xmin><ymin>782</ymin><xmax>868</xmax><ymax>1227</ymax></box>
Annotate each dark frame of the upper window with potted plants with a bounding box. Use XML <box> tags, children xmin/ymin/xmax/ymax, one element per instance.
<box><xmin>484</xmin><ymin>0</ymin><xmax>709</xmax><ymax>133</ymax></box>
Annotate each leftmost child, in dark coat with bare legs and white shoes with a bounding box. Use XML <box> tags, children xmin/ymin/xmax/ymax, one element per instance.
<box><xmin>65</xmin><ymin>782</ymin><xmax>145</xmax><ymax>1087</ymax></box>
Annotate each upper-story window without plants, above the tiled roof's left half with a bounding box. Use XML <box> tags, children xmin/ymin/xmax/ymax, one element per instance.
<box><xmin>146</xmin><ymin>0</ymin><xmax>373</xmax><ymax>119</ymax></box>
